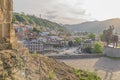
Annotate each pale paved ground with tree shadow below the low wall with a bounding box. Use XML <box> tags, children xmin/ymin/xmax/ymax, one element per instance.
<box><xmin>61</xmin><ymin>57</ymin><xmax>120</xmax><ymax>80</ymax></box>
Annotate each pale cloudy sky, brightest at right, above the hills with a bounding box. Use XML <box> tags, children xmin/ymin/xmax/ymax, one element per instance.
<box><xmin>14</xmin><ymin>0</ymin><xmax>120</xmax><ymax>24</ymax></box>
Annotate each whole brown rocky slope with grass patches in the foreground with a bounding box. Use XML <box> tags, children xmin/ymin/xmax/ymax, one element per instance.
<box><xmin>0</xmin><ymin>50</ymin><xmax>101</xmax><ymax>80</ymax></box>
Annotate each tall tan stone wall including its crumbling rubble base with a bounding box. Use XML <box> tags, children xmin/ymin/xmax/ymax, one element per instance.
<box><xmin>0</xmin><ymin>0</ymin><xmax>17</xmax><ymax>50</ymax></box>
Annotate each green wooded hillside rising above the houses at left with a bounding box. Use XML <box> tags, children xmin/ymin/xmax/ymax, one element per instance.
<box><xmin>13</xmin><ymin>13</ymin><xmax>66</xmax><ymax>32</ymax></box>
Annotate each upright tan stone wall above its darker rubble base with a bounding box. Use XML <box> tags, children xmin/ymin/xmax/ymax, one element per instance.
<box><xmin>0</xmin><ymin>0</ymin><xmax>15</xmax><ymax>38</ymax></box>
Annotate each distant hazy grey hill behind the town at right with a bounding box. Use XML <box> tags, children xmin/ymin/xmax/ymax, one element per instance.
<box><xmin>65</xmin><ymin>18</ymin><xmax>120</xmax><ymax>34</ymax></box>
